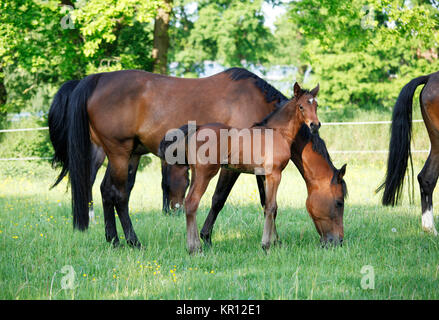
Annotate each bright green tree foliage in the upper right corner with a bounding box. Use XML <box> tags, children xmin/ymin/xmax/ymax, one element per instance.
<box><xmin>289</xmin><ymin>0</ymin><xmax>439</xmax><ymax>109</ymax></box>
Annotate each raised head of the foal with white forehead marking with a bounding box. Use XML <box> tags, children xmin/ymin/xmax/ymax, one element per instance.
<box><xmin>292</xmin><ymin>82</ymin><xmax>321</xmax><ymax>133</ymax></box>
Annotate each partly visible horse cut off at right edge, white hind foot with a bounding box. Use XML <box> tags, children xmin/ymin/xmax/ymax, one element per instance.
<box><xmin>377</xmin><ymin>72</ymin><xmax>439</xmax><ymax>235</ymax></box>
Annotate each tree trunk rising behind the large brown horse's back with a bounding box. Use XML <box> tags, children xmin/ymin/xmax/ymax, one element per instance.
<box><xmin>152</xmin><ymin>0</ymin><xmax>173</xmax><ymax>74</ymax></box>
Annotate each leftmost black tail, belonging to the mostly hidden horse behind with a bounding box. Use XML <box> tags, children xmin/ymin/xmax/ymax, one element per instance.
<box><xmin>48</xmin><ymin>80</ymin><xmax>79</xmax><ymax>188</ymax></box>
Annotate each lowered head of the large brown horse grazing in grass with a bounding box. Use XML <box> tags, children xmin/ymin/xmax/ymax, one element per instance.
<box><xmin>306</xmin><ymin>165</ymin><xmax>347</xmax><ymax>246</ymax></box>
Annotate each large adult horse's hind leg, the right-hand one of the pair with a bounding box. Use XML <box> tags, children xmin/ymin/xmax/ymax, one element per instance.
<box><xmin>108</xmin><ymin>153</ymin><xmax>141</xmax><ymax>248</ymax></box>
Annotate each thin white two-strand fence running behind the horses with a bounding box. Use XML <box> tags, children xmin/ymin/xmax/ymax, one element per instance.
<box><xmin>0</xmin><ymin>119</ymin><xmax>430</xmax><ymax>161</ymax></box>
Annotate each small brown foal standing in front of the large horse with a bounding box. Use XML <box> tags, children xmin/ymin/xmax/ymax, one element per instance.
<box><xmin>159</xmin><ymin>83</ymin><xmax>320</xmax><ymax>253</ymax></box>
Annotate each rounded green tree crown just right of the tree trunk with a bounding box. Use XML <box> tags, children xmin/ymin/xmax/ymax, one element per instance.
<box><xmin>171</xmin><ymin>0</ymin><xmax>273</xmax><ymax>74</ymax></box>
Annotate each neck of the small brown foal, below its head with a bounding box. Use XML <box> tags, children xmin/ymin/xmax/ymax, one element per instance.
<box><xmin>265</xmin><ymin>99</ymin><xmax>303</xmax><ymax>146</ymax></box>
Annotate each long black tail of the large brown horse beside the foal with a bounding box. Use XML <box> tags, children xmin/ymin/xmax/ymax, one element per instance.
<box><xmin>67</xmin><ymin>74</ymin><xmax>100</xmax><ymax>230</ymax></box>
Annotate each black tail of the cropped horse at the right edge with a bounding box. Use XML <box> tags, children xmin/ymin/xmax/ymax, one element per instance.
<box><xmin>376</xmin><ymin>76</ymin><xmax>429</xmax><ymax>206</ymax></box>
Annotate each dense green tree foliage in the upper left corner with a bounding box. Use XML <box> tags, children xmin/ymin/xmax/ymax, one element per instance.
<box><xmin>0</xmin><ymin>0</ymin><xmax>162</xmax><ymax>117</ymax></box>
